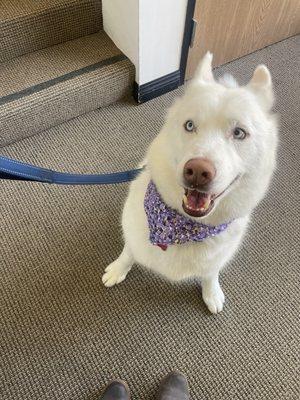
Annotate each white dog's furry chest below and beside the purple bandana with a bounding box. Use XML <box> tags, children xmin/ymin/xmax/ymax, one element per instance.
<box><xmin>122</xmin><ymin>176</ymin><xmax>246</xmax><ymax>280</ymax></box>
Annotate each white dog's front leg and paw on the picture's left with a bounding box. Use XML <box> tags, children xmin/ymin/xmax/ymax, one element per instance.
<box><xmin>102</xmin><ymin>244</ymin><xmax>134</xmax><ymax>287</ymax></box>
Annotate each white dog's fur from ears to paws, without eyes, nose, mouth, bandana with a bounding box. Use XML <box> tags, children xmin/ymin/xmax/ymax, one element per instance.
<box><xmin>103</xmin><ymin>53</ymin><xmax>277</xmax><ymax>313</ymax></box>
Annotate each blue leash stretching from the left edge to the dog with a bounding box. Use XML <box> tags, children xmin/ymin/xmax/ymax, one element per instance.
<box><xmin>0</xmin><ymin>156</ymin><xmax>143</xmax><ymax>185</ymax></box>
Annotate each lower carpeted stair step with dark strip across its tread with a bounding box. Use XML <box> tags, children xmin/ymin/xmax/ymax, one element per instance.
<box><xmin>0</xmin><ymin>31</ymin><xmax>134</xmax><ymax>146</ymax></box>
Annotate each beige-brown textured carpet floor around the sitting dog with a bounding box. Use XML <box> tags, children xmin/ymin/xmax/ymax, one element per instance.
<box><xmin>0</xmin><ymin>36</ymin><xmax>300</xmax><ymax>400</ymax></box>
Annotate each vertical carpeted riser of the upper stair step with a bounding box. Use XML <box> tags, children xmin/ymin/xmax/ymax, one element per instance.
<box><xmin>0</xmin><ymin>0</ymin><xmax>102</xmax><ymax>62</ymax></box>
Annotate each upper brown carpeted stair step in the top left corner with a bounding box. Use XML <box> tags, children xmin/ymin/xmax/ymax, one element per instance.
<box><xmin>0</xmin><ymin>0</ymin><xmax>102</xmax><ymax>62</ymax></box>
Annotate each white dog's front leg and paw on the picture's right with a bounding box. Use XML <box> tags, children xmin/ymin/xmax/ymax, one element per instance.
<box><xmin>201</xmin><ymin>272</ymin><xmax>225</xmax><ymax>314</ymax></box>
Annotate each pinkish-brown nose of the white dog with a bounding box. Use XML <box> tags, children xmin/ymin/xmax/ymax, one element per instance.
<box><xmin>183</xmin><ymin>158</ymin><xmax>216</xmax><ymax>189</ymax></box>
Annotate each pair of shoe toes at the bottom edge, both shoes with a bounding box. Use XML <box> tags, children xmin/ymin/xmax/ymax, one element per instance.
<box><xmin>99</xmin><ymin>372</ymin><xmax>189</xmax><ymax>400</ymax></box>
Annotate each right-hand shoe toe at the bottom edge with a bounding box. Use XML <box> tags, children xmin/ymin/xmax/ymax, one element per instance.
<box><xmin>157</xmin><ymin>372</ymin><xmax>189</xmax><ymax>400</ymax></box>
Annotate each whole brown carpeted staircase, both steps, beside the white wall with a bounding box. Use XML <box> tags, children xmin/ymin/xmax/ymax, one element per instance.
<box><xmin>0</xmin><ymin>0</ymin><xmax>134</xmax><ymax>147</ymax></box>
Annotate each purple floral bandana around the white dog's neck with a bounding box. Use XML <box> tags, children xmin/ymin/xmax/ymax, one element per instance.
<box><xmin>144</xmin><ymin>181</ymin><xmax>230</xmax><ymax>250</ymax></box>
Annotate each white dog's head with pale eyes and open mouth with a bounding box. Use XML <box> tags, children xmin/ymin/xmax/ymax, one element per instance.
<box><xmin>148</xmin><ymin>53</ymin><xmax>277</xmax><ymax>222</ymax></box>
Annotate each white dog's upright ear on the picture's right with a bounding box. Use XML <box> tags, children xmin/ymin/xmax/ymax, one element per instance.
<box><xmin>247</xmin><ymin>64</ymin><xmax>274</xmax><ymax>110</ymax></box>
